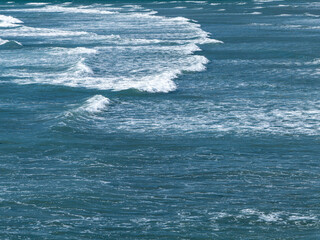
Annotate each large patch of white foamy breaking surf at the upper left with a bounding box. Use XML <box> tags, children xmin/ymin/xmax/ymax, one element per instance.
<box><xmin>0</xmin><ymin>3</ymin><xmax>222</xmax><ymax>92</ymax></box>
